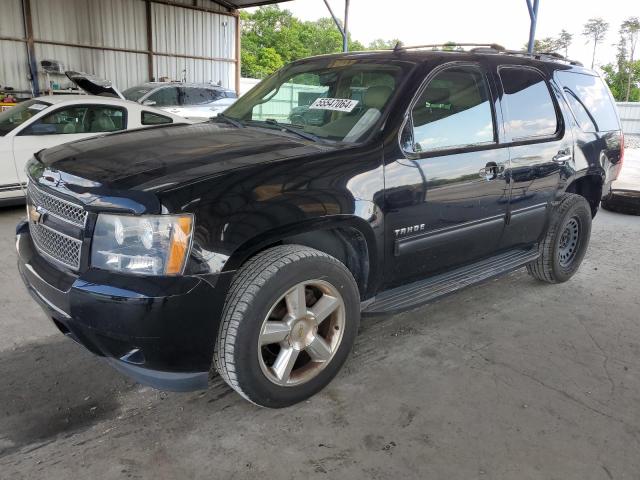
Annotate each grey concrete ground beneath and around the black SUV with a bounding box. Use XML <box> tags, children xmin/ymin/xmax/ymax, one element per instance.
<box><xmin>0</xmin><ymin>150</ymin><xmax>640</xmax><ymax>480</ymax></box>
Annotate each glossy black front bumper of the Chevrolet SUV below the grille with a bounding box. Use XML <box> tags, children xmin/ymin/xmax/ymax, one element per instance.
<box><xmin>16</xmin><ymin>223</ymin><xmax>231</xmax><ymax>391</ymax></box>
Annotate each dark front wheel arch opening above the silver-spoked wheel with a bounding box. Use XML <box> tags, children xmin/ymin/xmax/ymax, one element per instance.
<box><xmin>223</xmin><ymin>215</ymin><xmax>380</xmax><ymax>299</ymax></box>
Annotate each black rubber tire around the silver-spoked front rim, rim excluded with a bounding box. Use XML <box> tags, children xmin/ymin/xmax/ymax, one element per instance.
<box><xmin>214</xmin><ymin>245</ymin><xmax>360</xmax><ymax>408</ymax></box>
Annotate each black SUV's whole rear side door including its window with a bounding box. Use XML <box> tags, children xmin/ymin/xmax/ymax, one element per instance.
<box><xmin>497</xmin><ymin>65</ymin><xmax>573</xmax><ymax>248</ymax></box>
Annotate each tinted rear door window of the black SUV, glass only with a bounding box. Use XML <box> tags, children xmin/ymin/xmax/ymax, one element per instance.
<box><xmin>499</xmin><ymin>67</ymin><xmax>558</xmax><ymax>140</ymax></box>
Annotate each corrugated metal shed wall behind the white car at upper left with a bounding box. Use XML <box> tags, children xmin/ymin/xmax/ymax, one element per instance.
<box><xmin>0</xmin><ymin>0</ymin><xmax>236</xmax><ymax>90</ymax></box>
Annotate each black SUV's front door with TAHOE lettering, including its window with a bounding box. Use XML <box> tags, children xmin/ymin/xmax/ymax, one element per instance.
<box><xmin>385</xmin><ymin>62</ymin><xmax>509</xmax><ymax>287</ymax></box>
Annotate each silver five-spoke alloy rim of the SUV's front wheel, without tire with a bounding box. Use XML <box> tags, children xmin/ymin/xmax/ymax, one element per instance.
<box><xmin>258</xmin><ymin>280</ymin><xmax>345</xmax><ymax>386</ymax></box>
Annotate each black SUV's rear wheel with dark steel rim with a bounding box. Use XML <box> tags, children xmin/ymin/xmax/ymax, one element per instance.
<box><xmin>527</xmin><ymin>193</ymin><xmax>591</xmax><ymax>283</ymax></box>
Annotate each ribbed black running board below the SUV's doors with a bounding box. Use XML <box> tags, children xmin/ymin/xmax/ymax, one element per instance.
<box><xmin>362</xmin><ymin>247</ymin><xmax>540</xmax><ymax>315</ymax></box>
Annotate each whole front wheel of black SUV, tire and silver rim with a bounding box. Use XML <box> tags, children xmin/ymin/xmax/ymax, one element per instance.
<box><xmin>214</xmin><ymin>245</ymin><xmax>360</xmax><ymax>408</ymax></box>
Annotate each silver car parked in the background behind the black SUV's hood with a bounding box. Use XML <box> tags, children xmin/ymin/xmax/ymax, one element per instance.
<box><xmin>122</xmin><ymin>82</ymin><xmax>238</xmax><ymax>120</ymax></box>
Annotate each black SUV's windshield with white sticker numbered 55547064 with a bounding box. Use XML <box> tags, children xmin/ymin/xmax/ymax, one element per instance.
<box><xmin>224</xmin><ymin>58</ymin><xmax>402</xmax><ymax>142</ymax></box>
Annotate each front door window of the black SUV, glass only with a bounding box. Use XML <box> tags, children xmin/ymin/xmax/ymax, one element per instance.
<box><xmin>412</xmin><ymin>63</ymin><xmax>494</xmax><ymax>152</ymax></box>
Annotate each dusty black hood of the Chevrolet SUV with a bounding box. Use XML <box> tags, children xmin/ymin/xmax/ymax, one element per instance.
<box><xmin>38</xmin><ymin>122</ymin><xmax>336</xmax><ymax>199</ymax></box>
